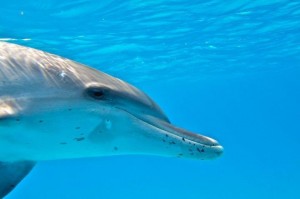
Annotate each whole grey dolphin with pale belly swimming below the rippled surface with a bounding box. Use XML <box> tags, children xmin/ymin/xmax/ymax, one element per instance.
<box><xmin>0</xmin><ymin>42</ymin><xmax>223</xmax><ymax>198</ymax></box>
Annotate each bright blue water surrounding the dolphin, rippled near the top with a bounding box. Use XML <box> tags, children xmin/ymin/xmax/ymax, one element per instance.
<box><xmin>0</xmin><ymin>0</ymin><xmax>300</xmax><ymax>199</ymax></box>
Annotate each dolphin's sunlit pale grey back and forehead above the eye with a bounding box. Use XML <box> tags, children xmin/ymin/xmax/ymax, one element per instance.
<box><xmin>0</xmin><ymin>42</ymin><xmax>154</xmax><ymax>104</ymax></box>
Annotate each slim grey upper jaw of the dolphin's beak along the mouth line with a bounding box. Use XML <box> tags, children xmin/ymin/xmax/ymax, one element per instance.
<box><xmin>115</xmin><ymin>107</ymin><xmax>222</xmax><ymax>149</ymax></box>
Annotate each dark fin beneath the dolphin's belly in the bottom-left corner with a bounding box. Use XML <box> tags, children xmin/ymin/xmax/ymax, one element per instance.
<box><xmin>0</xmin><ymin>161</ymin><xmax>35</xmax><ymax>198</ymax></box>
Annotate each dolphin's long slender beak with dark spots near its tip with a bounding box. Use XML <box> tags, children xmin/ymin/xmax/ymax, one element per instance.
<box><xmin>121</xmin><ymin>109</ymin><xmax>223</xmax><ymax>160</ymax></box>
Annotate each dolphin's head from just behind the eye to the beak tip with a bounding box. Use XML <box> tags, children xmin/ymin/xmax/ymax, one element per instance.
<box><xmin>72</xmin><ymin>66</ymin><xmax>223</xmax><ymax>159</ymax></box>
